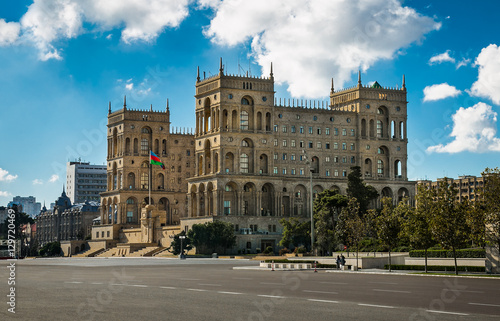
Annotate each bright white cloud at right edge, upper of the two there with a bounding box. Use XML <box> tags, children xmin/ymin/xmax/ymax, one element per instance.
<box><xmin>470</xmin><ymin>44</ymin><xmax>500</xmax><ymax>105</ymax></box>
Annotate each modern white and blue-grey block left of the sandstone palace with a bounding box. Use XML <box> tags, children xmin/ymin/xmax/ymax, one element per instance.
<box><xmin>66</xmin><ymin>161</ymin><xmax>106</xmax><ymax>204</ymax></box>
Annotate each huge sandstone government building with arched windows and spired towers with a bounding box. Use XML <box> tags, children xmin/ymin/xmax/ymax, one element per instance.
<box><xmin>89</xmin><ymin>60</ymin><xmax>415</xmax><ymax>255</ymax></box>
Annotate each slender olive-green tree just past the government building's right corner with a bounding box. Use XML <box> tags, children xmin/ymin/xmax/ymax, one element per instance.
<box><xmin>403</xmin><ymin>185</ymin><xmax>435</xmax><ymax>273</ymax></box>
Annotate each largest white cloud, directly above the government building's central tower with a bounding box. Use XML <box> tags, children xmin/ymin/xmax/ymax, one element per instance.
<box><xmin>199</xmin><ymin>0</ymin><xmax>441</xmax><ymax>97</ymax></box>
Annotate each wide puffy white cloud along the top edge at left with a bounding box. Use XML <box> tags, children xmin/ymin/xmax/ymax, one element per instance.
<box><xmin>13</xmin><ymin>0</ymin><xmax>191</xmax><ymax>60</ymax></box>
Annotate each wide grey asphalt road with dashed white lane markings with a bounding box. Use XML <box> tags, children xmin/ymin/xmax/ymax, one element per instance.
<box><xmin>0</xmin><ymin>258</ymin><xmax>500</xmax><ymax>321</ymax></box>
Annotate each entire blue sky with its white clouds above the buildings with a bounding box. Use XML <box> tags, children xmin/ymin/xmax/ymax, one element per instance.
<box><xmin>0</xmin><ymin>0</ymin><xmax>500</xmax><ymax>205</ymax></box>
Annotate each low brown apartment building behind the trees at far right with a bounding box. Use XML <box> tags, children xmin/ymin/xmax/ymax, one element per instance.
<box><xmin>417</xmin><ymin>175</ymin><xmax>484</xmax><ymax>202</ymax></box>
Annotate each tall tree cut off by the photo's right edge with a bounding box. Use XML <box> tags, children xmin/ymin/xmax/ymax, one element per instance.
<box><xmin>482</xmin><ymin>167</ymin><xmax>500</xmax><ymax>262</ymax></box>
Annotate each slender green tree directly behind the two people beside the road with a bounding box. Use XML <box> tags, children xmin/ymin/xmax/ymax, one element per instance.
<box><xmin>336</xmin><ymin>197</ymin><xmax>366</xmax><ymax>267</ymax></box>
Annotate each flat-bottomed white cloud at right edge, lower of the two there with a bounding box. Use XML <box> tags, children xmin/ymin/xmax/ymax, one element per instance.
<box><xmin>427</xmin><ymin>103</ymin><xmax>500</xmax><ymax>154</ymax></box>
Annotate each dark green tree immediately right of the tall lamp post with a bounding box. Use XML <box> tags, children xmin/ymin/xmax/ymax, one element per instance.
<box><xmin>314</xmin><ymin>190</ymin><xmax>349</xmax><ymax>252</ymax></box>
